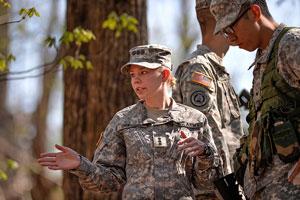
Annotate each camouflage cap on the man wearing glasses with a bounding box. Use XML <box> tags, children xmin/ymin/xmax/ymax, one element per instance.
<box><xmin>210</xmin><ymin>0</ymin><xmax>251</xmax><ymax>34</ymax></box>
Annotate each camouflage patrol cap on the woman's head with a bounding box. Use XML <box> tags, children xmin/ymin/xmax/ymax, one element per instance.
<box><xmin>121</xmin><ymin>44</ymin><xmax>172</xmax><ymax>74</ymax></box>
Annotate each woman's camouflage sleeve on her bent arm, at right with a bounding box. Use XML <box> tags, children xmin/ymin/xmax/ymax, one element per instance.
<box><xmin>194</xmin><ymin>115</ymin><xmax>223</xmax><ymax>191</ymax></box>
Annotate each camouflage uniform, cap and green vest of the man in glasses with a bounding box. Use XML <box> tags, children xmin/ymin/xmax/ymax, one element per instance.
<box><xmin>211</xmin><ymin>0</ymin><xmax>300</xmax><ymax>200</ymax></box>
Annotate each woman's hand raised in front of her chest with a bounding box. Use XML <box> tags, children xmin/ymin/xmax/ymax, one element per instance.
<box><xmin>177</xmin><ymin>137</ymin><xmax>206</xmax><ymax>157</ymax></box>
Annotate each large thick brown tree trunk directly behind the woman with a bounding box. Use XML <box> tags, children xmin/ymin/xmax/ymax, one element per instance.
<box><xmin>63</xmin><ymin>0</ymin><xmax>147</xmax><ymax>200</ymax></box>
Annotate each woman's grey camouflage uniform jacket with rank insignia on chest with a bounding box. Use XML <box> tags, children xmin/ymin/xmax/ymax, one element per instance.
<box><xmin>73</xmin><ymin>100</ymin><xmax>220</xmax><ymax>200</ymax></box>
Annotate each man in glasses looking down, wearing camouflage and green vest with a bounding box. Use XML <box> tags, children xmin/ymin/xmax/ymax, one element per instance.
<box><xmin>211</xmin><ymin>0</ymin><xmax>300</xmax><ymax>200</ymax></box>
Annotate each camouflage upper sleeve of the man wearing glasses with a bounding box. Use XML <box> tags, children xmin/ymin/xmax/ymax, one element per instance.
<box><xmin>277</xmin><ymin>28</ymin><xmax>300</xmax><ymax>89</ymax></box>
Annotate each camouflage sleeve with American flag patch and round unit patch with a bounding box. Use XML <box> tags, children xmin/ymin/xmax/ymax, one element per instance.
<box><xmin>173</xmin><ymin>62</ymin><xmax>234</xmax><ymax>174</ymax></box>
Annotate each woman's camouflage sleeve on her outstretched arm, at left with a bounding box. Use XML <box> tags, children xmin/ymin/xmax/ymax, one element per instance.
<box><xmin>71</xmin><ymin>116</ymin><xmax>126</xmax><ymax>192</ymax></box>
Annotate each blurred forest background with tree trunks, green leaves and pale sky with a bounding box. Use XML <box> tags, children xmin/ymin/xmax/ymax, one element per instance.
<box><xmin>0</xmin><ymin>0</ymin><xmax>300</xmax><ymax>200</ymax></box>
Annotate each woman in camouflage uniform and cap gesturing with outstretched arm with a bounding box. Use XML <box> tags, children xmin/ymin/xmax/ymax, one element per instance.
<box><xmin>38</xmin><ymin>45</ymin><xmax>221</xmax><ymax>200</ymax></box>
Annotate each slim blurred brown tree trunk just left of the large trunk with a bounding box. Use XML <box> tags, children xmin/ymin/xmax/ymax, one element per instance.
<box><xmin>31</xmin><ymin>1</ymin><xmax>58</xmax><ymax>200</ymax></box>
